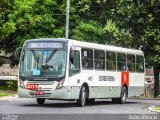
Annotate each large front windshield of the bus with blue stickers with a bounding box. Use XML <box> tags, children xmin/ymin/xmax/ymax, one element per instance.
<box><xmin>20</xmin><ymin>49</ymin><xmax>66</xmax><ymax>78</ymax></box>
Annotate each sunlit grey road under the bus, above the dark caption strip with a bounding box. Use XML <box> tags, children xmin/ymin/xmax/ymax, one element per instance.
<box><xmin>0</xmin><ymin>98</ymin><xmax>160</xmax><ymax>120</ymax></box>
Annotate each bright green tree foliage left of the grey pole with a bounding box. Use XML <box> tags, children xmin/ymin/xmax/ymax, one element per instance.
<box><xmin>1</xmin><ymin>0</ymin><xmax>65</xmax><ymax>52</ymax></box>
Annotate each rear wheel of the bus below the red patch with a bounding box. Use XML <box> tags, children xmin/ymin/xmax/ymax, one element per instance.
<box><xmin>117</xmin><ymin>87</ymin><xmax>127</xmax><ymax>104</ymax></box>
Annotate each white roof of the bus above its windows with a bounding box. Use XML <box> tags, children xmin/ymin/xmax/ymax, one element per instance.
<box><xmin>25</xmin><ymin>38</ymin><xmax>144</xmax><ymax>55</ymax></box>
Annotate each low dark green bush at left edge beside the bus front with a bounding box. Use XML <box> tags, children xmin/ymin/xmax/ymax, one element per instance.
<box><xmin>0</xmin><ymin>80</ymin><xmax>17</xmax><ymax>91</ymax></box>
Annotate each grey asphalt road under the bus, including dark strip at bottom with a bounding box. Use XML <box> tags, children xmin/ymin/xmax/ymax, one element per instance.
<box><xmin>0</xmin><ymin>98</ymin><xmax>160</xmax><ymax>120</ymax></box>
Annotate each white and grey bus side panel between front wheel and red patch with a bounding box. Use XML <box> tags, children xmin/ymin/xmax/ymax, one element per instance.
<box><xmin>82</xmin><ymin>70</ymin><xmax>121</xmax><ymax>98</ymax></box>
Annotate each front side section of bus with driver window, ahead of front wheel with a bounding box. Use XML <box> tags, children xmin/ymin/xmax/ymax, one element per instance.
<box><xmin>69</xmin><ymin>47</ymin><xmax>81</xmax><ymax>99</ymax></box>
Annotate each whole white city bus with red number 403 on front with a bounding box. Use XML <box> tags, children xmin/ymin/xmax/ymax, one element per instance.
<box><xmin>18</xmin><ymin>38</ymin><xmax>144</xmax><ymax>107</ymax></box>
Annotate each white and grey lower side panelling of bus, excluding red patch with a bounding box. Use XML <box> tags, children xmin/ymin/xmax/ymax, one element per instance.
<box><xmin>69</xmin><ymin>70</ymin><xmax>144</xmax><ymax>99</ymax></box>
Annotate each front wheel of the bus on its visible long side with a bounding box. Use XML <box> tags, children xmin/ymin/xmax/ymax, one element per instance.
<box><xmin>77</xmin><ymin>86</ymin><xmax>87</xmax><ymax>107</ymax></box>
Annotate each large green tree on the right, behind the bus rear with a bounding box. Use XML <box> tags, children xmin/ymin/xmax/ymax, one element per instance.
<box><xmin>71</xmin><ymin>0</ymin><xmax>160</xmax><ymax>96</ymax></box>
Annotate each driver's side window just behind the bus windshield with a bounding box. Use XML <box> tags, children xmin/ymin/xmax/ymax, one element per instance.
<box><xmin>69</xmin><ymin>50</ymin><xmax>80</xmax><ymax>76</ymax></box>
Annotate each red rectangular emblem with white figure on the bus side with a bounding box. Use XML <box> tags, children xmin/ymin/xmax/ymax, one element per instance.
<box><xmin>121</xmin><ymin>72</ymin><xmax>129</xmax><ymax>86</ymax></box>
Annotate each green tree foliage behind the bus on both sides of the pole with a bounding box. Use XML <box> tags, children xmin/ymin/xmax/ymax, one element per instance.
<box><xmin>0</xmin><ymin>0</ymin><xmax>160</xmax><ymax>67</ymax></box>
